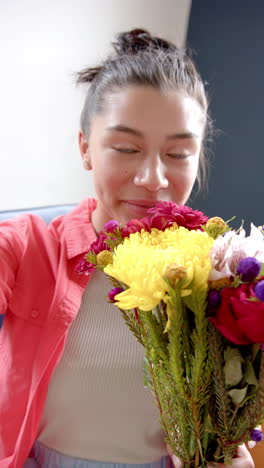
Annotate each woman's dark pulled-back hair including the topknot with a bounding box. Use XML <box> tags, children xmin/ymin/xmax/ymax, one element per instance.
<box><xmin>77</xmin><ymin>29</ymin><xmax>211</xmax><ymax>187</ymax></box>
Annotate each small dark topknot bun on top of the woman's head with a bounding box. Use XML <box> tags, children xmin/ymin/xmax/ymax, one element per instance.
<box><xmin>113</xmin><ymin>29</ymin><xmax>177</xmax><ymax>55</ymax></box>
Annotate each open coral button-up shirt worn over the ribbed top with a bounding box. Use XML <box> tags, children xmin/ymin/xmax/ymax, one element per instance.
<box><xmin>0</xmin><ymin>199</ymin><xmax>96</xmax><ymax>468</ymax></box>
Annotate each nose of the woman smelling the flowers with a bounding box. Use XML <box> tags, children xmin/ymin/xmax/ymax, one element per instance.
<box><xmin>134</xmin><ymin>154</ymin><xmax>169</xmax><ymax>192</ymax></box>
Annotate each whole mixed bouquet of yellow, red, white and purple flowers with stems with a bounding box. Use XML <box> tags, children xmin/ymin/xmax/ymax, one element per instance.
<box><xmin>77</xmin><ymin>202</ymin><xmax>264</xmax><ymax>468</ymax></box>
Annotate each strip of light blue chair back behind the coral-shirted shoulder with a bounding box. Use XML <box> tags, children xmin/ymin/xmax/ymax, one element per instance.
<box><xmin>0</xmin><ymin>203</ymin><xmax>76</xmax><ymax>224</ymax></box>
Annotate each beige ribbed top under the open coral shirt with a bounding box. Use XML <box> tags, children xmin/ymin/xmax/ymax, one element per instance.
<box><xmin>38</xmin><ymin>271</ymin><xmax>167</xmax><ymax>463</ymax></box>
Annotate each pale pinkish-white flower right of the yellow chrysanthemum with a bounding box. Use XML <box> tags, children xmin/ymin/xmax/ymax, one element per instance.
<box><xmin>209</xmin><ymin>223</ymin><xmax>264</xmax><ymax>281</ymax></box>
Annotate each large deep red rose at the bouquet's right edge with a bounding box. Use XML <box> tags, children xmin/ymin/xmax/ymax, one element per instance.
<box><xmin>209</xmin><ymin>278</ymin><xmax>264</xmax><ymax>345</ymax></box>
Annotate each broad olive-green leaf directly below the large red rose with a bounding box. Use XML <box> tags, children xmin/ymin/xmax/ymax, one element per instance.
<box><xmin>224</xmin><ymin>346</ymin><xmax>244</xmax><ymax>387</ymax></box>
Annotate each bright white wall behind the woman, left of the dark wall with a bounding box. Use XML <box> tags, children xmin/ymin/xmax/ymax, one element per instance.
<box><xmin>0</xmin><ymin>0</ymin><xmax>191</xmax><ymax>210</ymax></box>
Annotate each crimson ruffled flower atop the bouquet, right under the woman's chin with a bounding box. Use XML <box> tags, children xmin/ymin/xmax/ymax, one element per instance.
<box><xmin>148</xmin><ymin>202</ymin><xmax>209</xmax><ymax>230</ymax></box>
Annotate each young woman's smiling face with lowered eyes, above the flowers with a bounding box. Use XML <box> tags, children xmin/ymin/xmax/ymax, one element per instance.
<box><xmin>79</xmin><ymin>86</ymin><xmax>204</xmax><ymax>231</ymax></box>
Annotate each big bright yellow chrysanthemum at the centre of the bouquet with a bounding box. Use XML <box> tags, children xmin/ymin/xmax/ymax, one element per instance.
<box><xmin>104</xmin><ymin>226</ymin><xmax>214</xmax><ymax>310</ymax></box>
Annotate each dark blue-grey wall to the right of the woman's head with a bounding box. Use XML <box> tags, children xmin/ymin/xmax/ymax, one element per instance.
<box><xmin>187</xmin><ymin>0</ymin><xmax>264</xmax><ymax>227</ymax></box>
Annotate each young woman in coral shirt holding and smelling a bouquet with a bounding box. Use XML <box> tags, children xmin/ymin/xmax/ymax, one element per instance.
<box><xmin>0</xmin><ymin>29</ymin><xmax>254</xmax><ymax>468</ymax></box>
